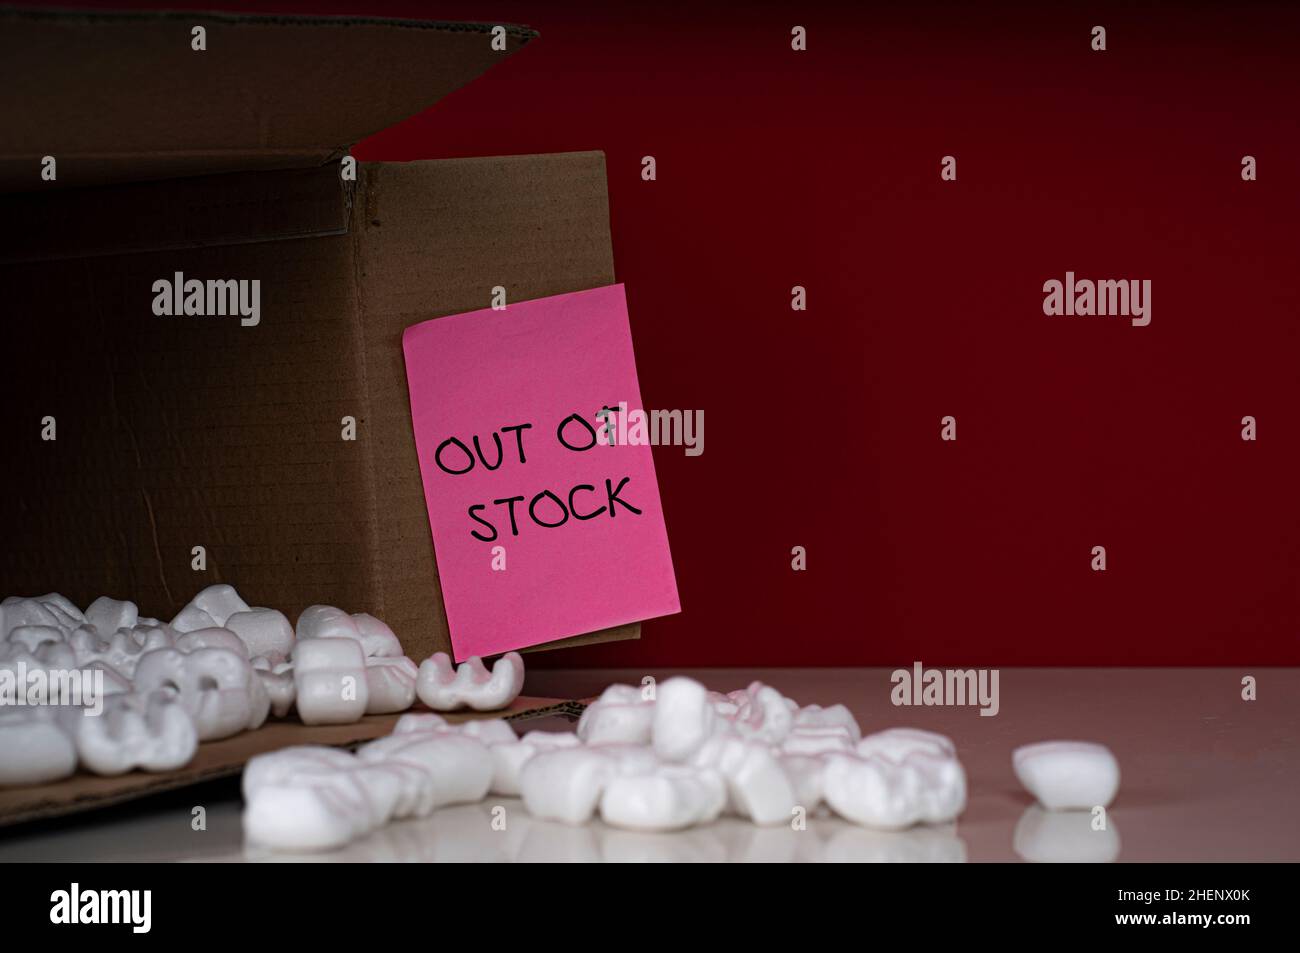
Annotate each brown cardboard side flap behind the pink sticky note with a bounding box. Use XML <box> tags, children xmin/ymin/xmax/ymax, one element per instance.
<box><xmin>352</xmin><ymin>152</ymin><xmax>640</xmax><ymax>660</ymax></box>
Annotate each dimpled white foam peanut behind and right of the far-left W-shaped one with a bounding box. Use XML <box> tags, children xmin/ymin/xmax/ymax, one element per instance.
<box><xmin>135</xmin><ymin>649</ymin><xmax>270</xmax><ymax>741</ymax></box>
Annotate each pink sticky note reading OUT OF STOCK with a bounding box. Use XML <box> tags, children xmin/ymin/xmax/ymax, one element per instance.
<box><xmin>402</xmin><ymin>285</ymin><xmax>680</xmax><ymax>659</ymax></box>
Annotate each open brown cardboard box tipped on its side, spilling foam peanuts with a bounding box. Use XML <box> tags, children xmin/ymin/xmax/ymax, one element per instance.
<box><xmin>0</xmin><ymin>12</ymin><xmax>640</xmax><ymax>659</ymax></box>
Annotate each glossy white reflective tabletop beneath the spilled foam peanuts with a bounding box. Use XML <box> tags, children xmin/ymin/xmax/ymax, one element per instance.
<box><xmin>0</xmin><ymin>668</ymin><xmax>1300</xmax><ymax>862</ymax></box>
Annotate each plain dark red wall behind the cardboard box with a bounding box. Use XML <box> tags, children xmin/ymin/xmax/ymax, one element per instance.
<box><xmin>55</xmin><ymin>0</ymin><xmax>1300</xmax><ymax>666</ymax></box>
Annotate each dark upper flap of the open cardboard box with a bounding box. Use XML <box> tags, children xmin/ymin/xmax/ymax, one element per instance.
<box><xmin>0</xmin><ymin>9</ymin><xmax>537</xmax><ymax>191</ymax></box>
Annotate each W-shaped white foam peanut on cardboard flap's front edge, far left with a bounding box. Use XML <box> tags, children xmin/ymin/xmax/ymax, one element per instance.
<box><xmin>75</xmin><ymin>692</ymin><xmax>199</xmax><ymax>775</ymax></box>
